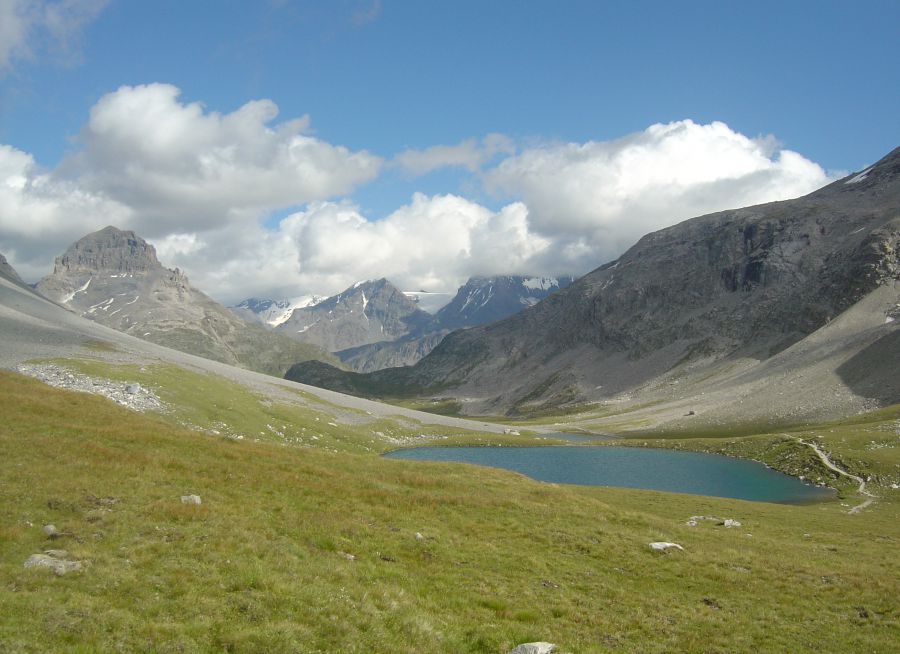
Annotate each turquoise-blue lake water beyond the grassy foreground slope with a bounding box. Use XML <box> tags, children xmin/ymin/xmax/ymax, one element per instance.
<box><xmin>385</xmin><ymin>446</ymin><xmax>834</xmax><ymax>503</ymax></box>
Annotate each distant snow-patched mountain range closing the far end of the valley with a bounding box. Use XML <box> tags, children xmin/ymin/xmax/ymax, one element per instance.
<box><xmin>232</xmin><ymin>276</ymin><xmax>572</xmax><ymax>372</ymax></box>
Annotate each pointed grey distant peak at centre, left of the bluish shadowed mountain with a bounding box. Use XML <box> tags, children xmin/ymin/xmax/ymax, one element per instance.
<box><xmin>276</xmin><ymin>279</ymin><xmax>431</xmax><ymax>352</ymax></box>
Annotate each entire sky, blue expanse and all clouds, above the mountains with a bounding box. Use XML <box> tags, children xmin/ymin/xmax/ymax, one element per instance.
<box><xmin>0</xmin><ymin>0</ymin><xmax>900</xmax><ymax>304</ymax></box>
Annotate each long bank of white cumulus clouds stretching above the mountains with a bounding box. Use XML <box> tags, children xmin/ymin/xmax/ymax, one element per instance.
<box><xmin>0</xmin><ymin>109</ymin><xmax>829</xmax><ymax>303</ymax></box>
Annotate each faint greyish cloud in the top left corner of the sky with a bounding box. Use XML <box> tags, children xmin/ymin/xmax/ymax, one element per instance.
<box><xmin>0</xmin><ymin>0</ymin><xmax>108</xmax><ymax>74</ymax></box>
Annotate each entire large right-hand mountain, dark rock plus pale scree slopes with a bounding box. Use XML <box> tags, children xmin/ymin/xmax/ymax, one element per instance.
<box><xmin>287</xmin><ymin>148</ymin><xmax>900</xmax><ymax>424</ymax></box>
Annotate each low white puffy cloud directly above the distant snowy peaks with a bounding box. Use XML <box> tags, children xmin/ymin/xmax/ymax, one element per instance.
<box><xmin>157</xmin><ymin>193</ymin><xmax>549</xmax><ymax>302</ymax></box>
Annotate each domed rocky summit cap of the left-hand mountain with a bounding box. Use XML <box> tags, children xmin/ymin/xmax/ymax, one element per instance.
<box><xmin>53</xmin><ymin>226</ymin><xmax>162</xmax><ymax>275</ymax></box>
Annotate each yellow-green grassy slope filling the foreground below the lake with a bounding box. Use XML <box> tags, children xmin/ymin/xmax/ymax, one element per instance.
<box><xmin>0</xmin><ymin>370</ymin><xmax>900</xmax><ymax>652</ymax></box>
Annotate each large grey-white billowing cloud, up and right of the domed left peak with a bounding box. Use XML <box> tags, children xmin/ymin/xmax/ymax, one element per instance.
<box><xmin>60</xmin><ymin>84</ymin><xmax>382</xmax><ymax>235</ymax></box>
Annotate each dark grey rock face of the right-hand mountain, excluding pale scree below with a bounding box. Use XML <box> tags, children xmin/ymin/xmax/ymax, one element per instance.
<box><xmin>289</xmin><ymin>149</ymin><xmax>900</xmax><ymax>420</ymax></box>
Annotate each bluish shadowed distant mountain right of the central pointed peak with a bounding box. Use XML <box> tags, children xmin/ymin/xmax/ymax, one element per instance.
<box><xmin>335</xmin><ymin>276</ymin><xmax>572</xmax><ymax>372</ymax></box>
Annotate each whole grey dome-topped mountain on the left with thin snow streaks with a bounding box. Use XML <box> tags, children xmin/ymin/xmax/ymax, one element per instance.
<box><xmin>37</xmin><ymin>227</ymin><xmax>340</xmax><ymax>374</ymax></box>
